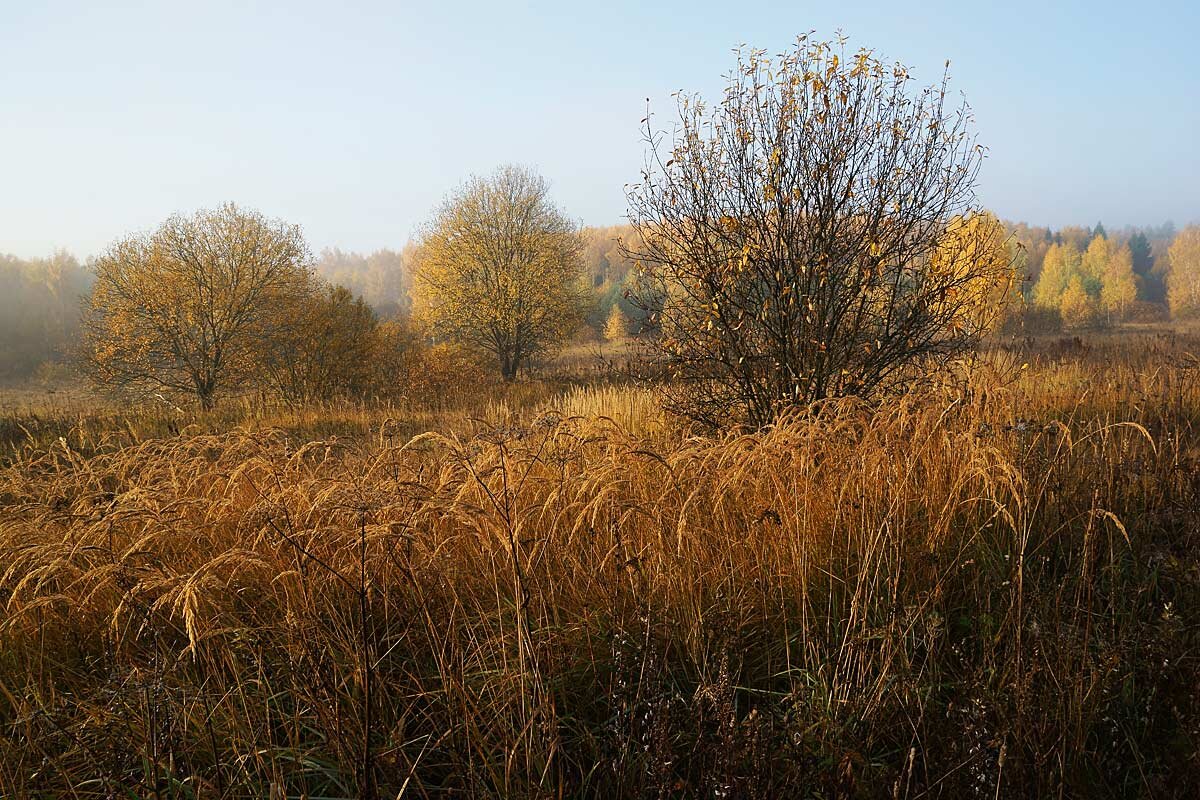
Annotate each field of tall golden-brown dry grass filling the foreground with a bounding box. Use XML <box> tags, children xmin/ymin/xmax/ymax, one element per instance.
<box><xmin>0</xmin><ymin>330</ymin><xmax>1200</xmax><ymax>798</ymax></box>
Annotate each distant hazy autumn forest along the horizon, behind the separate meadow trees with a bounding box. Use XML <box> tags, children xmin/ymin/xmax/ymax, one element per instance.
<box><xmin>7</xmin><ymin>222</ymin><xmax>1200</xmax><ymax>393</ymax></box>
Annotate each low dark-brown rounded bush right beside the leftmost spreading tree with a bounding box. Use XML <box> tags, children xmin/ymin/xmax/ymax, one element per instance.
<box><xmin>262</xmin><ymin>278</ymin><xmax>379</xmax><ymax>403</ymax></box>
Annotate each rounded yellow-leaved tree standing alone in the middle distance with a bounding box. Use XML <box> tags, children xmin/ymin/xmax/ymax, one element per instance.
<box><xmin>413</xmin><ymin>167</ymin><xmax>583</xmax><ymax>380</ymax></box>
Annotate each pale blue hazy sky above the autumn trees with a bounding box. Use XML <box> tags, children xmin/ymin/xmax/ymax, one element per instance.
<box><xmin>0</xmin><ymin>0</ymin><xmax>1200</xmax><ymax>258</ymax></box>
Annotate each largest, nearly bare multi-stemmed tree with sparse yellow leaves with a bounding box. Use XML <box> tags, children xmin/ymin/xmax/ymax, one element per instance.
<box><xmin>629</xmin><ymin>37</ymin><xmax>1008</xmax><ymax>426</ymax></box>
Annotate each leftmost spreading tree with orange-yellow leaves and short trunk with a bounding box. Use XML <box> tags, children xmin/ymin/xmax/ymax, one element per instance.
<box><xmin>84</xmin><ymin>204</ymin><xmax>311</xmax><ymax>409</ymax></box>
